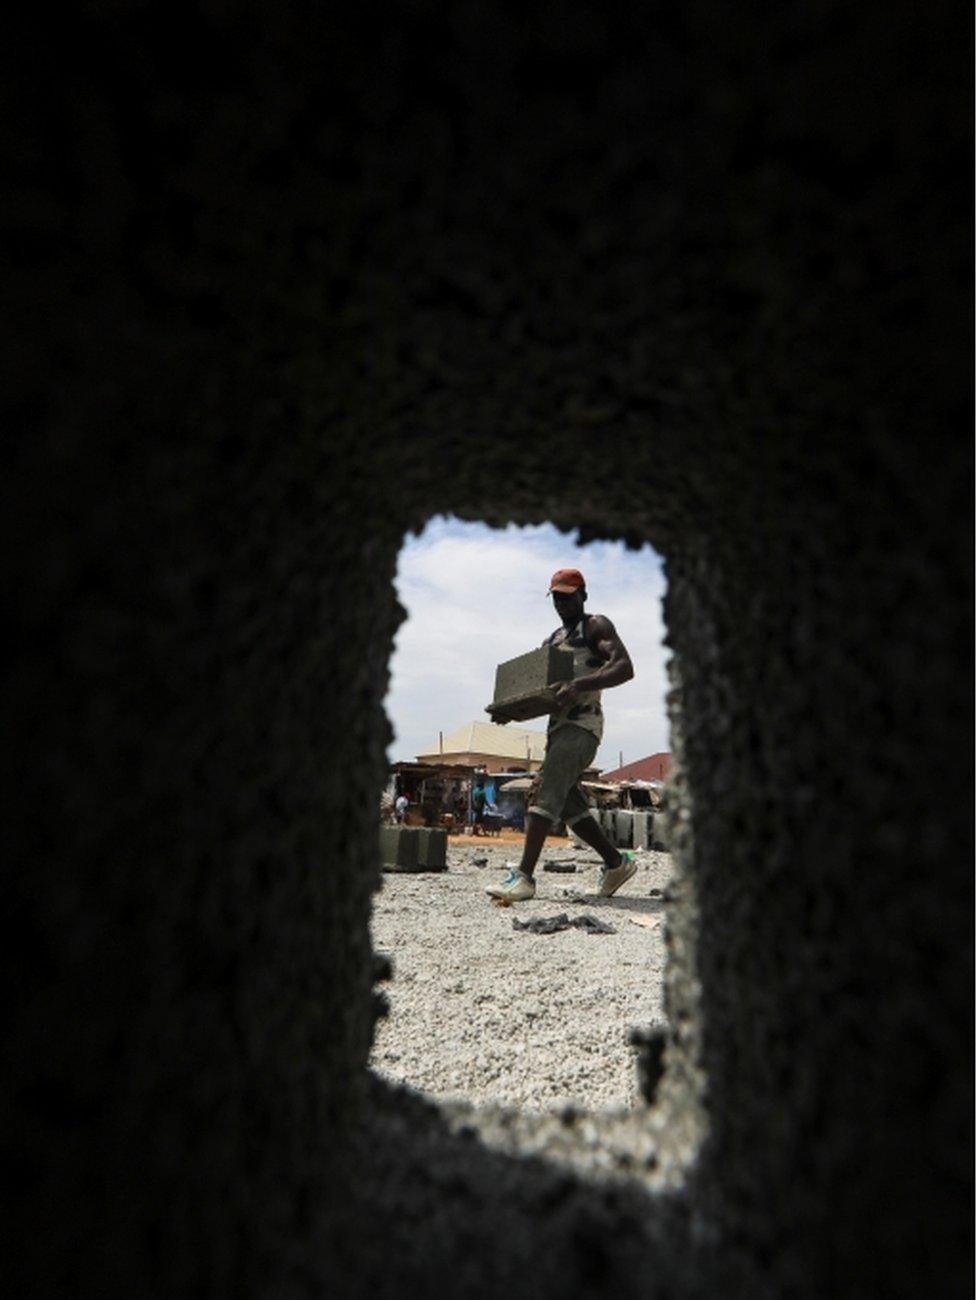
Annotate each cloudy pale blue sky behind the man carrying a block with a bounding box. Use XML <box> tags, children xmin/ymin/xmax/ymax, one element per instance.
<box><xmin>386</xmin><ymin>516</ymin><xmax>668</xmax><ymax>770</ymax></box>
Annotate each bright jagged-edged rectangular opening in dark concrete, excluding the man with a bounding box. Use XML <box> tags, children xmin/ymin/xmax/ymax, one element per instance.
<box><xmin>370</xmin><ymin>517</ymin><xmax>701</xmax><ymax>1190</ymax></box>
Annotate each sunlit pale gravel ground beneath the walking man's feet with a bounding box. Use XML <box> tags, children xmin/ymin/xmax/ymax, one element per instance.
<box><xmin>370</xmin><ymin>840</ymin><xmax>671</xmax><ymax>1114</ymax></box>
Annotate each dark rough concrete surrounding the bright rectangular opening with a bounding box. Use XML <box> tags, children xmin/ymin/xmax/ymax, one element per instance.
<box><xmin>4</xmin><ymin>3</ymin><xmax>972</xmax><ymax>1296</ymax></box>
